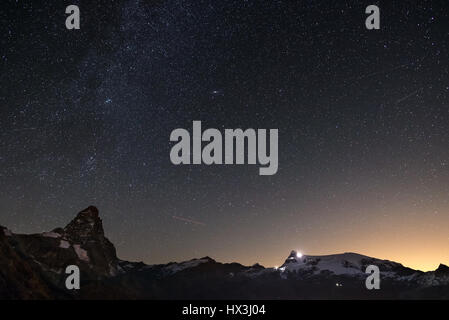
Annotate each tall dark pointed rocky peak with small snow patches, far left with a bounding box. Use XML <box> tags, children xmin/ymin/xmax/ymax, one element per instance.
<box><xmin>0</xmin><ymin>206</ymin><xmax>120</xmax><ymax>298</ymax></box>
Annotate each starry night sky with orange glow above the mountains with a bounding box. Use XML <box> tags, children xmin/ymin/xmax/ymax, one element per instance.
<box><xmin>0</xmin><ymin>0</ymin><xmax>449</xmax><ymax>270</ymax></box>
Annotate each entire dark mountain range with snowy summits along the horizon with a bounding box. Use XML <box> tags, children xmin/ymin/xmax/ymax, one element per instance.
<box><xmin>0</xmin><ymin>206</ymin><xmax>449</xmax><ymax>299</ymax></box>
